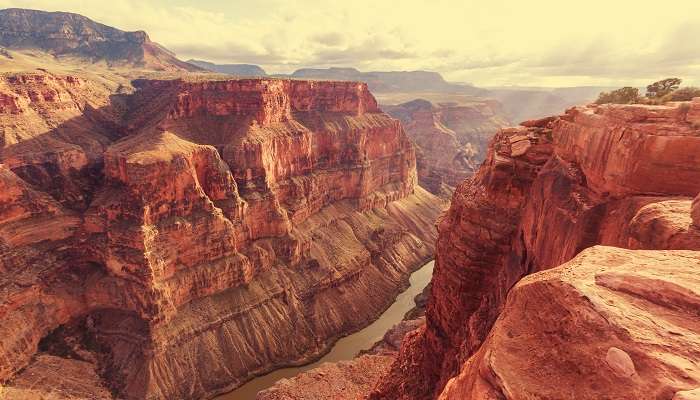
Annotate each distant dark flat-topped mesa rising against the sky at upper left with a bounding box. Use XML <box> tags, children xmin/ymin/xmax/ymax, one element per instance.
<box><xmin>0</xmin><ymin>8</ymin><xmax>200</xmax><ymax>71</ymax></box>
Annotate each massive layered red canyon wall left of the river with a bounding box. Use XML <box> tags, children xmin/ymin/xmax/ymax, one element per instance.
<box><xmin>0</xmin><ymin>73</ymin><xmax>440</xmax><ymax>399</ymax></box>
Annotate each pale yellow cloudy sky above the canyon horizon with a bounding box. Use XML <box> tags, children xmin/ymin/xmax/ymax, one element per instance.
<box><xmin>0</xmin><ymin>0</ymin><xmax>700</xmax><ymax>87</ymax></box>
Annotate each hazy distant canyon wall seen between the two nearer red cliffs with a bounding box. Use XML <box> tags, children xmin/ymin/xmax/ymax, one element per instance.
<box><xmin>383</xmin><ymin>100</ymin><xmax>508</xmax><ymax>198</ymax></box>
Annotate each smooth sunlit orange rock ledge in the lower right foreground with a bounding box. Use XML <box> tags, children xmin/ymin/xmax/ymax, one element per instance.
<box><xmin>439</xmin><ymin>246</ymin><xmax>700</xmax><ymax>400</ymax></box>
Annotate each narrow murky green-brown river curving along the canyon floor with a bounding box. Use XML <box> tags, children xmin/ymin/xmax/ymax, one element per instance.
<box><xmin>221</xmin><ymin>261</ymin><xmax>435</xmax><ymax>400</ymax></box>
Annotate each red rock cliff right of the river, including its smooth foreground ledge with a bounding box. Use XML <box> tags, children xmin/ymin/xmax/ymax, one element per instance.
<box><xmin>370</xmin><ymin>102</ymin><xmax>700</xmax><ymax>399</ymax></box>
